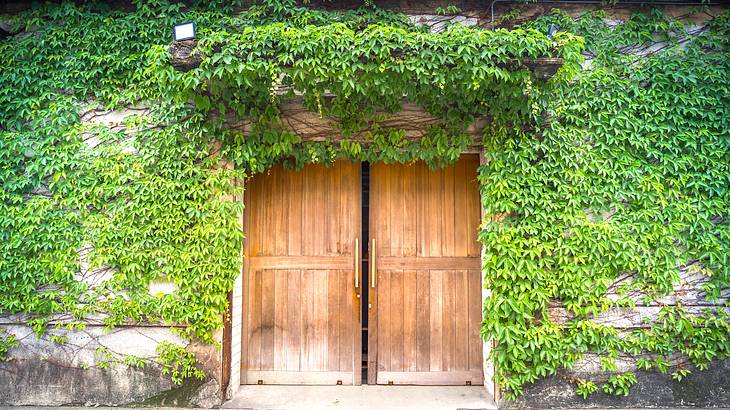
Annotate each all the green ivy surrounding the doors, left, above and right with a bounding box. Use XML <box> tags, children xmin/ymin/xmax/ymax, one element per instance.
<box><xmin>0</xmin><ymin>0</ymin><xmax>730</xmax><ymax>395</ymax></box>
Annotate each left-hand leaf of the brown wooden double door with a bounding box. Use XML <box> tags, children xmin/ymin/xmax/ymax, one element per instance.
<box><xmin>241</xmin><ymin>162</ymin><xmax>360</xmax><ymax>384</ymax></box>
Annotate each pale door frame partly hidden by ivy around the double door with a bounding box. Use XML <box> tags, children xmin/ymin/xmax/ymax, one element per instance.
<box><xmin>222</xmin><ymin>152</ymin><xmax>500</xmax><ymax>402</ymax></box>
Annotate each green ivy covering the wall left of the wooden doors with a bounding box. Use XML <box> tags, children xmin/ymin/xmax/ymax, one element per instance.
<box><xmin>0</xmin><ymin>3</ymin><xmax>247</xmax><ymax>340</ymax></box>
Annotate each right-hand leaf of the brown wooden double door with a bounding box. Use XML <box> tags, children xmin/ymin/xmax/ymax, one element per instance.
<box><xmin>368</xmin><ymin>156</ymin><xmax>483</xmax><ymax>385</ymax></box>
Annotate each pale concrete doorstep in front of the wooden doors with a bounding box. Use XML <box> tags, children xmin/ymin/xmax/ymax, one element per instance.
<box><xmin>223</xmin><ymin>385</ymin><xmax>497</xmax><ymax>410</ymax></box>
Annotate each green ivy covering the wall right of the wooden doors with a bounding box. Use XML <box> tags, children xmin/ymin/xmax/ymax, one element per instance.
<box><xmin>480</xmin><ymin>8</ymin><xmax>730</xmax><ymax>397</ymax></box>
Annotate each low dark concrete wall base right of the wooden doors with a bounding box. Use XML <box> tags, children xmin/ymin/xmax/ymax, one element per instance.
<box><xmin>499</xmin><ymin>360</ymin><xmax>730</xmax><ymax>409</ymax></box>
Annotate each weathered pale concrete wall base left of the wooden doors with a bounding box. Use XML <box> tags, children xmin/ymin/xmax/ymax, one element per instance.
<box><xmin>0</xmin><ymin>324</ymin><xmax>221</xmax><ymax>407</ymax></box>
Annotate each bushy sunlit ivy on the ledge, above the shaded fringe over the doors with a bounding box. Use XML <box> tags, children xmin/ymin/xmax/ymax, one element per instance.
<box><xmin>151</xmin><ymin>10</ymin><xmax>582</xmax><ymax>130</ymax></box>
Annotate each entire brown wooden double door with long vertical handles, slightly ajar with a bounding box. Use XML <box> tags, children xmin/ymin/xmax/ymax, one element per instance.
<box><xmin>241</xmin><ymin>156</ymin><xmax>483</xmax><ymax>385</ymax></box>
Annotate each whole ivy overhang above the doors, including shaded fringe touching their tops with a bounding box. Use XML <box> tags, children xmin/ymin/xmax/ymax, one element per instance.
<box><xmin>152</xmin><ymin>1</ymin><xmax>582</xmax><ymax>171</ymax></box>
